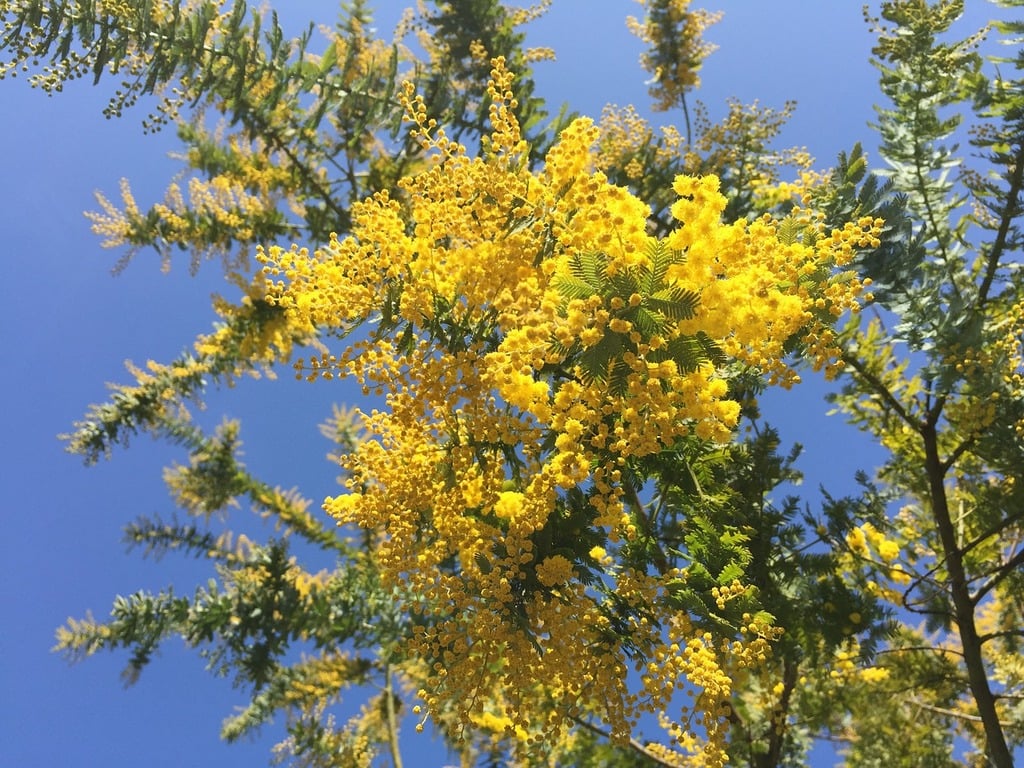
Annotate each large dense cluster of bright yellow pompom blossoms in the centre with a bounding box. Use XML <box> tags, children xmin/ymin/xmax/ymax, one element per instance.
<box><xmin>260</xmin><ymin>59</ymin><xmax>863</xmax><ymax>765</ymax></box>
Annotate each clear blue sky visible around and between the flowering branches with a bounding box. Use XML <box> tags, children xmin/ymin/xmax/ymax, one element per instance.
<box><xmin>0</xmin><ymin>0</ymin><xmax>1003</xmax><ymax>768</ymax></box>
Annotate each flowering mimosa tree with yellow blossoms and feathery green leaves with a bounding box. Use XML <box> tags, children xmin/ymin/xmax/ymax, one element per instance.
<box><xmin>0</xmin><ymin>0</ymin><xmax>1024</xmax><ymax>768</ymax></box>
